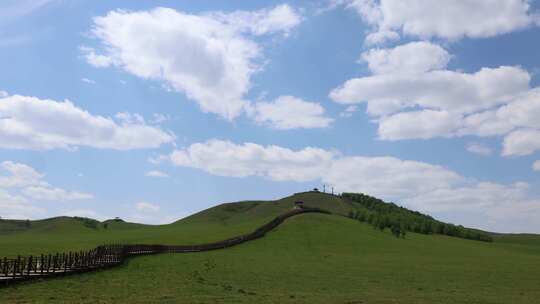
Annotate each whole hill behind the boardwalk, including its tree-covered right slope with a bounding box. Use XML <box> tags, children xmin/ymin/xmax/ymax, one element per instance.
<box><xmin>0</xmin><ymin>191</ymin><xmax>490</xmax><ymax>255</ymax></box>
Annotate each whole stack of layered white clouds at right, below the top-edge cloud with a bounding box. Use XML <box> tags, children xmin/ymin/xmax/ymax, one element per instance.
<box><xmin>330</xmin><ymin>42</ymin><xmax>540</xmax><ymax>156</ymax></box>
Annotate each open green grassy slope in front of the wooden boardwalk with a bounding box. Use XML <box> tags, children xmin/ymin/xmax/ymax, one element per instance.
<box><xmin>0</xmin><ymin>215</ymin><xmax>540</xmax><ymax>304</ymax></box>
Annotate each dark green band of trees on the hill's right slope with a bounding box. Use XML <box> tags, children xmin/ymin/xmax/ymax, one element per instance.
<box><xmin>342</xmin><ymin>193</ymin><xmax>493</xmax><ymax>242</ymax></box>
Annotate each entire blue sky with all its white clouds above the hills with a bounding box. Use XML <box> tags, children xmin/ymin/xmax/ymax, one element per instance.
<box><xmin>0</xmin><ymin>0</ymin><xmax>540</xmax><ymax>232</ymax></box>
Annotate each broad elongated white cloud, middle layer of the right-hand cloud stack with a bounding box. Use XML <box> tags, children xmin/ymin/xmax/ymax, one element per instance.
<box><xmin>330</xmin><ymin>66</ymin><xmax>530</xmax><ymax>115</ymax></box>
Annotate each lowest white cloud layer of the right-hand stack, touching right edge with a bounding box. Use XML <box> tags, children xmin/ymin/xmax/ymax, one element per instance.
<box><xmin>368</xmin><ymin>89</ymin><xmax>540</xmax><ymax>156</ymax></box>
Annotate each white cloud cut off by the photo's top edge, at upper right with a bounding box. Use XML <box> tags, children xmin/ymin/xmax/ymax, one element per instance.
<box><xmin>340</xmin><ymin>0</ymin><xmax>538</xmax><ymax>44</ymax></box>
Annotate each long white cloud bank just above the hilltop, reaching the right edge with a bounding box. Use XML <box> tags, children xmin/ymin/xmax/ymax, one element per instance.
<box><xmin>157</xmin><ymin>140</ymin><xmax>540</xmax><ymax>231</ymax></box>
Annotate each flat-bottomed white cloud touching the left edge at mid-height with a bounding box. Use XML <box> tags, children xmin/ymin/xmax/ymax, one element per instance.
<box><xmin>0</xmin><ymin>95</ymin><xmax>174</xmax><ymax>150</ymax></box>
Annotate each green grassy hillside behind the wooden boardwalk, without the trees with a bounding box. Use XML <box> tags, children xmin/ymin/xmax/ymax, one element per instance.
<box><xmin>0</xmin><ymin>192</ymin><xmax>352</xmax><ymax>257</ymax></box>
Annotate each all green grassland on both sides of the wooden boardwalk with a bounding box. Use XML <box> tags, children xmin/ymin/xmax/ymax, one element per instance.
<box><xmin>0</xmin><ymin>193</ymin><xmax>540</xmax><ymax>304</ymax></box>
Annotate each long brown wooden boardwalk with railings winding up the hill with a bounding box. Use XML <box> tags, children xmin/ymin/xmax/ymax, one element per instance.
<box><xmin>0</xmin><ymin>207</ymin><xmax>330</xmax><ymax>287</ymax></box>
